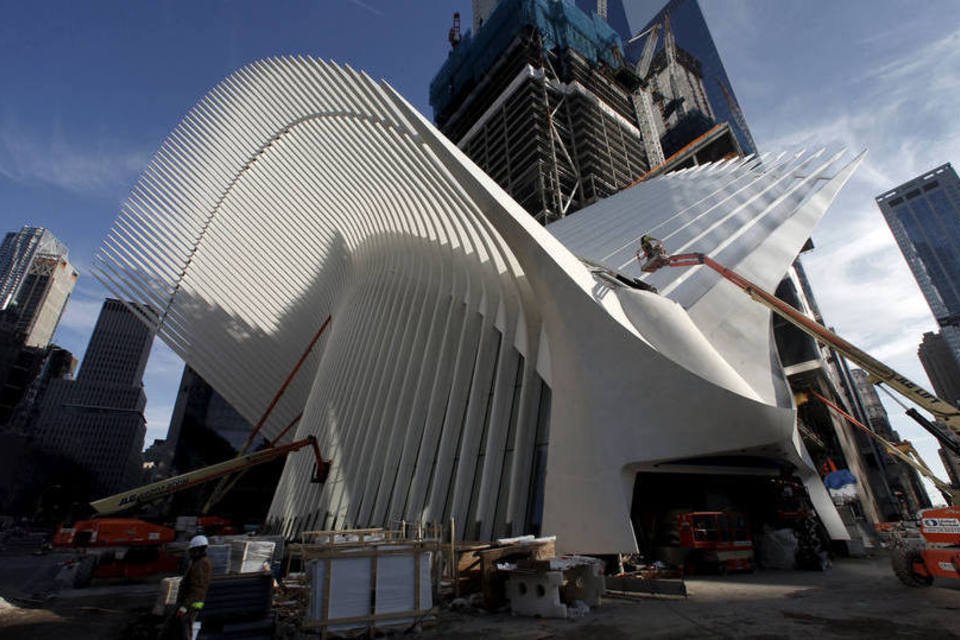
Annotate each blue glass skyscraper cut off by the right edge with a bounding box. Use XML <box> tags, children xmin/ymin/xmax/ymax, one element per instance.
<box><xmin>876</xmin><ymin>163</ymin><xmax>960</xmax><ymax>358</ymax></box>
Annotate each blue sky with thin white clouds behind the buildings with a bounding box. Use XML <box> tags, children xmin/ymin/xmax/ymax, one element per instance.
<box><xmin>0</xmin><ymin>0</ymin><xmax>960</xmax><ymax>496</ymax></box>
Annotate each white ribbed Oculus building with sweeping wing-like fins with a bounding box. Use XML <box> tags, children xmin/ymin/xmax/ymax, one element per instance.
<box><xmin>97</xmin><ymin>57</ymin><xmax>858</xmax><ymax>553</ymax></box>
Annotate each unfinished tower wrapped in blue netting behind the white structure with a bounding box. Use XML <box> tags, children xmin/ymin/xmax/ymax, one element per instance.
<box><xmin>430</xmin><ymin>0</ymin><xmax>656</xmax><ymax>224</ymax></box>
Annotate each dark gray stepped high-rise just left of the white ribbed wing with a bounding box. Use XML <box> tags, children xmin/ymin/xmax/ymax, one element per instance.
<box><xmin>35</xmin><ymin>299</ymin><xmax>153</xmax><ymax>496</ymax></box>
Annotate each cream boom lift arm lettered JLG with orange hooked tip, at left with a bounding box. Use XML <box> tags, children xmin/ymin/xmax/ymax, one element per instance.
<box><xmin>90</xmin><ymin>436</ymin><xmax>330</xmax><ymax>515</ymax></box>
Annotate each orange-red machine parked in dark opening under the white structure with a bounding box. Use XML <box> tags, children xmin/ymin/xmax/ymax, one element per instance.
<box><xmin>677</xmin><ymin>511</ymin><xmax>754</xmax><ymax>574</ymax></box>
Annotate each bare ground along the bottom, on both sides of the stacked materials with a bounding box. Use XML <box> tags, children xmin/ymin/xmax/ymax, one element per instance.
<box><xmin>0</xmin><ymin>555</ymin><xmax>960</xmax><ymax>640</ymax></box>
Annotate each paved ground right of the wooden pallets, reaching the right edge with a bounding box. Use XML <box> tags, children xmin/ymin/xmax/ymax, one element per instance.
<box><xmin>421</xmin><ymin>558</ymin><xmax>960</xmax><ymax>640</ymax></box>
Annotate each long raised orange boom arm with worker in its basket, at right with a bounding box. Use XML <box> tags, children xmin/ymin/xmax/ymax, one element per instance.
<box><xmin>637</xmin><ymin>238</ymin><xmax>960</xmax><ymax>448</ymax></box>
